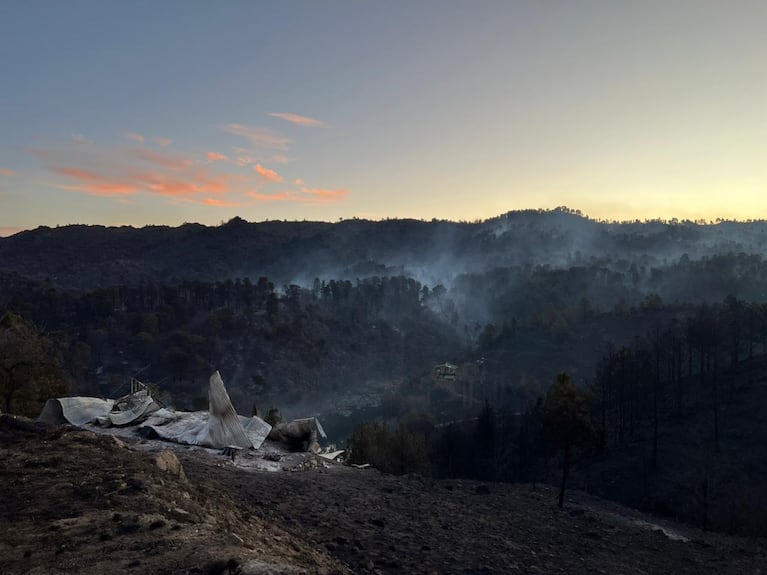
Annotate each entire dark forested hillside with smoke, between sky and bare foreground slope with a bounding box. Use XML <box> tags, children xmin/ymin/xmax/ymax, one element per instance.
<box><xmin>0</xmin><ymin>208</ymin><xmax>767</xmax><ymax>534</ymax></box>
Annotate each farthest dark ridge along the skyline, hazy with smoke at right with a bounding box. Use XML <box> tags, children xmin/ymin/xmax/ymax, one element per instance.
<box><xmin>0</xmin><ymin>209</ymin><xmax>767</xmax><ymax>289</ymax></box>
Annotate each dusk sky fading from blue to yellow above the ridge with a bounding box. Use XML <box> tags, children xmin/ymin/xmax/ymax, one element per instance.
<box><xmin>0</xmin><ymin>0</ymin><xmax>767</xmax><ymax>235</ymax></box>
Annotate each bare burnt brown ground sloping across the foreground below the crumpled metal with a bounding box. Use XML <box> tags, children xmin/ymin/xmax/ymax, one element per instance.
<box><xmin>0</xmin><ymin>416</ymin><xmax>767</xmax><ymax>574</ymax></box>
